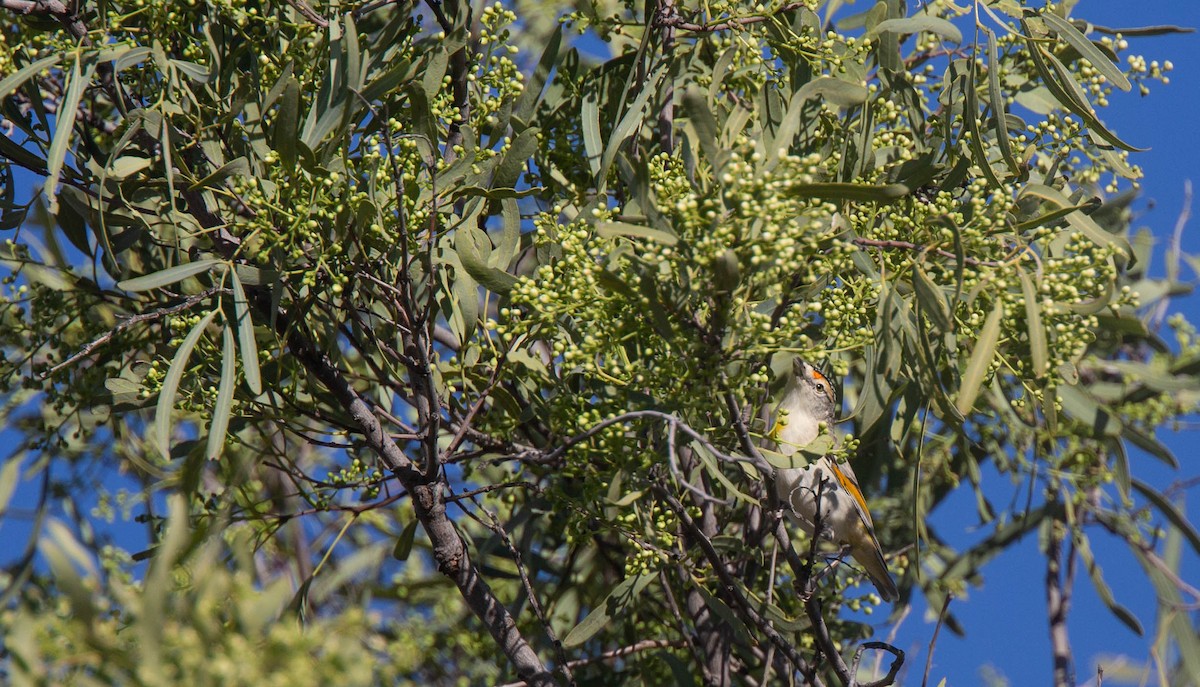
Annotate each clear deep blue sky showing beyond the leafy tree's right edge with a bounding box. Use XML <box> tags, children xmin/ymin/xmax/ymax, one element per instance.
<box><xmin>0</xmin><ymin>0</ymin><xmax>1200</xmax><ymax>686</ymax></box>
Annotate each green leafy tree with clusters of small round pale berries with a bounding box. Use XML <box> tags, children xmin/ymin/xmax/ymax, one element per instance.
<box><xmin>0</xmin><ymin>0</ymin><xmax>1200</xmax><ymax>685</ymax></box>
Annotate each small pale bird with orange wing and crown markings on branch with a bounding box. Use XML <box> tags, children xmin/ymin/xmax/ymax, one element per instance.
<box><xmin>768</xmin><ymin>358</ymin><xmax>900</xmax><ymax>602</ymax></box>
